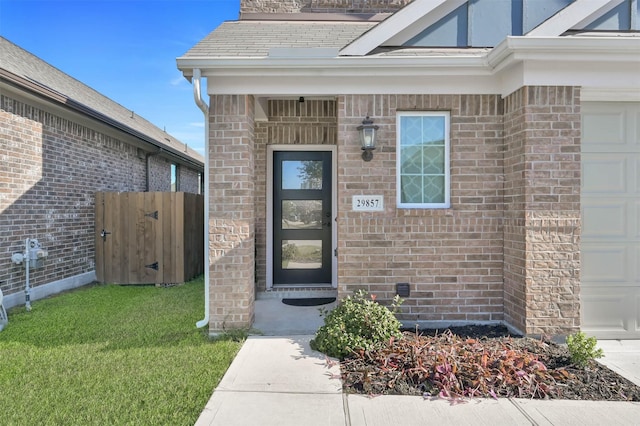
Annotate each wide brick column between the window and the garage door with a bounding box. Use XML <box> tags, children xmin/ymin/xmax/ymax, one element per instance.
<box><xmin>504</xmin><ymin>86</ymin><xmax>580</xmax><ymax>335</ymax></box>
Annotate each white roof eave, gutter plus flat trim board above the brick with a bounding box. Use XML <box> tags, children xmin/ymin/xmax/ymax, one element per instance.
<box><xmin>178</xmin><ymin>36</ymin><xmax>640</xmax><ymax>96</ymax></box>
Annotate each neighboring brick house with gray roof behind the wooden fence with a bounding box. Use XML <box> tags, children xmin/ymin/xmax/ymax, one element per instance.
<box><xmin>0</xmin><ymin>38</ymin><xmax>204</xmax><ymax>307</ymax></box>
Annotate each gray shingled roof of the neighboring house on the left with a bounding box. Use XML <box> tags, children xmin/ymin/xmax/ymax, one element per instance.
<box><xmin>0</xmin><ymin>37</ymin><xmax>204</xmax><ymax>163</ymax></box>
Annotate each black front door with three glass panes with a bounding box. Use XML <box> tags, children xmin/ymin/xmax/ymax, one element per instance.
<box><xmin>273</xmin><ymin>151</ymin><xmax>332</xmax><ymax>285</ymax></box>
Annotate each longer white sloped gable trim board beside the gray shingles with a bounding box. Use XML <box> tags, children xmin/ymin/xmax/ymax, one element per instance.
<box><xmin>340</xmin><ymin>0</ymin><xmax>467</xmax><ymax>56</ymax></box>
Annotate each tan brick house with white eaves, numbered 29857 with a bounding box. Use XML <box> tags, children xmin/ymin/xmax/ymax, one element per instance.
<box><xmin>178</xmin><ymin>0</ymin><xmax>640</xmax><ymax>338</ymax></box>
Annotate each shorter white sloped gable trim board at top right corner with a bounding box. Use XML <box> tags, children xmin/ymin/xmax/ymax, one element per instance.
<box><xmin>526</xmin><ymin>0</ymin><xmax>624</xmax><ymax>37</ymax></box>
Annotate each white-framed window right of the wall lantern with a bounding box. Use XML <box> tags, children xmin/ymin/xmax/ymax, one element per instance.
<box><xmin>396</xmin><ymin>111</ymin><xmax>451</xmax><ymax>209</ymax></box>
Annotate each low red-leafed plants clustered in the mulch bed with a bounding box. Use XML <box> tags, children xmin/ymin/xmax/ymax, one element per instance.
<box><xmin>343</xmin><ymin>331</ymin><xmax>571</xmax><ymax>400</ymax></box>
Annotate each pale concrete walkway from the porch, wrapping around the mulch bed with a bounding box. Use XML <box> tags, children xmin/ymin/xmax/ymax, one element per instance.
<box><xmin>196</xmin><ymin>301</ymin><xmax>640</xmax><ymax>426</ymax></box>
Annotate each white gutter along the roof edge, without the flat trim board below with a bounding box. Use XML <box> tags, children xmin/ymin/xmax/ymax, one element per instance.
<box><xmin>177</xmin><ymin>36</ymin><xmax>640</xmax><ymax>78</ymax></box>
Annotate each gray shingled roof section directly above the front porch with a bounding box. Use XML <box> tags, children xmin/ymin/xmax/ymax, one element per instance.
<box><xmin>182</xmin><ymin>21</ymin><xmax>378</xmax><ymax>59</ymax></box>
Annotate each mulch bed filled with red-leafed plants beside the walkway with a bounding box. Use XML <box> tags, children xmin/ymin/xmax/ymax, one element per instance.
<box><xmin>341</xmin><ymin>326</ymin><xmax>640</xmax><ymax>401</ymax></box>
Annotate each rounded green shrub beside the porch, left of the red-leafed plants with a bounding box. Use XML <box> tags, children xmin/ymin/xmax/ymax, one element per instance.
<box><xmin>311</xmin><ymin>290</ymin><xmax>402</xmax><ymax>359</ymax></box>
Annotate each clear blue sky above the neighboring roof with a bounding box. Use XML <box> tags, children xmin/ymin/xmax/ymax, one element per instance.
<box><xmin>0</xmin><ymin>0</ymin><xmax>240</xmax><ymax>153</ymax></box>
